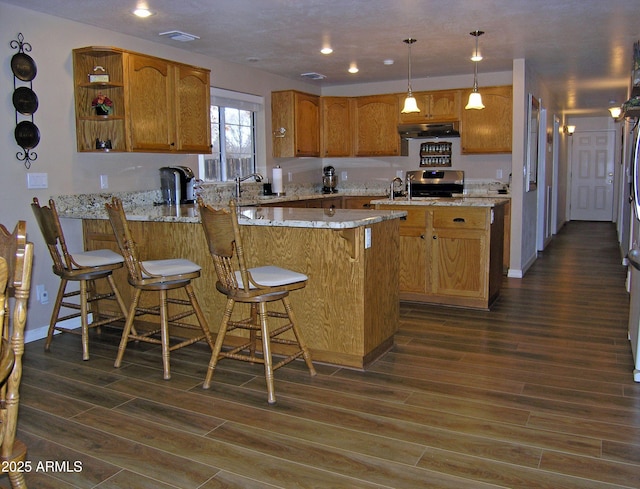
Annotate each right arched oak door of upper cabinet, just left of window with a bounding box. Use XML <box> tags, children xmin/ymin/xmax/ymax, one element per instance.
<box><xmin>176</xmin><ymin>65</ymin><xmax>211</xmax><ymax>153</ymax></box>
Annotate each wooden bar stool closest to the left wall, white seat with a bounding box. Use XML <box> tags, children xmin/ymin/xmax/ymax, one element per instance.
<box><xmin>31</xmin><ymin>198</ymin><xmax>127</xmax><ymax>360</ymax></box>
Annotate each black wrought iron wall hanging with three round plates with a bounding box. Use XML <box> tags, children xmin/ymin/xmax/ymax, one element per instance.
<box><xmin>9</xmin><ymin>33</ymin><xmax>40</xmax><ymax>169</ymax></box>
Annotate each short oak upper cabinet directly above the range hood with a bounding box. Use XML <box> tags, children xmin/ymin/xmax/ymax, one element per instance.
<box><xmin>399</xmin><ymin>90</ymin><xmax>462</xmax><ymax>124</ymax></box>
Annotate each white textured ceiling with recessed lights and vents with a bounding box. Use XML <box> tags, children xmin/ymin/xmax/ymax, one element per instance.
<box><xmin>6</xmin><ymin>0</ymin><xmax>640</xmax><ymax>115</ymax></box>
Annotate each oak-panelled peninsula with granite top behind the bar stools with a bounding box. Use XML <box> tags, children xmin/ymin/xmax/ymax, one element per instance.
<box><xmin>58</xmin><ymin>194</ymin><xmax>406</xmax><ymax>369</ymax></box>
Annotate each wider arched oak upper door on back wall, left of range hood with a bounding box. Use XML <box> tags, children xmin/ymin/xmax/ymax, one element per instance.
<box><xmin>354</xmin><ymin>94</ymin><xmax>400</xmax><ymax>156</ymax></box>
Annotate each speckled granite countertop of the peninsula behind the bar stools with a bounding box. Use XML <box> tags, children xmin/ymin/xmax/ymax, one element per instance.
<box><xmin>59</xmin><ymin>204</ymin><xmax>407</xmax><ymax>229</ymax></box>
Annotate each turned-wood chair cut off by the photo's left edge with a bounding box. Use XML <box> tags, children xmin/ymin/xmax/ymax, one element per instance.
<box><xmin>0</xmin><ymin>221</ymin><xmax>33</xmax><ymax>489</ymax></box>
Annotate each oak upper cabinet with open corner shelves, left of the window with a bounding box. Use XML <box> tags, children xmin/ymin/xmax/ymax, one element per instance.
<box><xmin>73</xmin><ymin>47</ymin><xmax>211</xmax><ymax>153</ymax></box>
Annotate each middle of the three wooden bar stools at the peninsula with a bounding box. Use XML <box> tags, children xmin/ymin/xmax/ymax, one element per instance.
<box><xmin>106</xmin><ymin>197</ymin><xmax>214</xmax><ymax>380</ymax></box>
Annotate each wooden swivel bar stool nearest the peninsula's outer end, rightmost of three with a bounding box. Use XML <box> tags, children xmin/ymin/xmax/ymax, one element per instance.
<box><xmin>198</xmin><ymin>199</ymin><xmax>316</xmax><ymax>404</ymax></box>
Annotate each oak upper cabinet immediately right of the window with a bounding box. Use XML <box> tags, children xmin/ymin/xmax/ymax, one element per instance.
<box><xmin>271</xmin><ymin>90</ymin><xmax>320</xmax><ymax>154</ymax></box>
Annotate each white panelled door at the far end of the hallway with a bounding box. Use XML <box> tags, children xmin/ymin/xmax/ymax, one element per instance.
<box><xmin>570</xmin><ymin>131</ymin><xmax>615</xmax><ymax>221</ymax></box>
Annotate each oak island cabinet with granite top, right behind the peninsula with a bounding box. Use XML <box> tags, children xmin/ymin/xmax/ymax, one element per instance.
<box><xmin>376</xmin><ymin>204</ymin><xmax>504</xmax><ymax>310</ymax></box>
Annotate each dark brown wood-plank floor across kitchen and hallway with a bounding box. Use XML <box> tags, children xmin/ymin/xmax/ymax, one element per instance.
<box><xmin>0</xmin><ymin>222</ymin><xmax>640</xmax><ymax>489</ymax></box>
